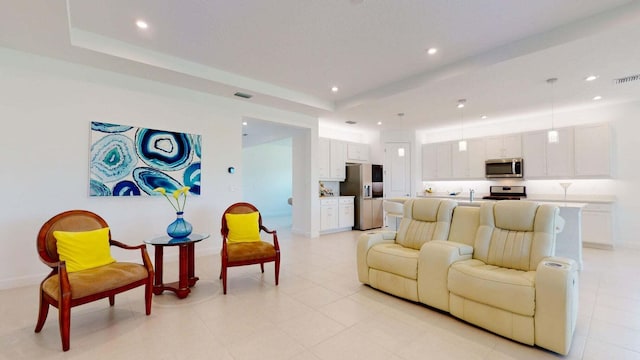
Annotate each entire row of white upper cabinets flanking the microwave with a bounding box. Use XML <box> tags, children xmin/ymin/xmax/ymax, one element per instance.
<box><xmin>422</xmin><ymin>124</ymin><xmax>611</xmax><ymax>181</ymax></box>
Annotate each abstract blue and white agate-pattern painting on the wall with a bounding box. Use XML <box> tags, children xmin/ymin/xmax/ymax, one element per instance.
<box><xmin>89</xmin><ymin>121</ymin><xmax>202</xmax><ymax>196</ymax></box>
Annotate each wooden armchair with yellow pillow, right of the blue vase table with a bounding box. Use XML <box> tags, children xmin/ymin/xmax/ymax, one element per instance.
<box><xmin>220</xmin><ymin>202</ymin><xmax>280</xmax><ymax>294</ymax></box>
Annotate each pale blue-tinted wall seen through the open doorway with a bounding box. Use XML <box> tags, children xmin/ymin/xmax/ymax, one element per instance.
<box><xmin>242</xmin><ymin>138</ymin><xmax>293</xmax><ymax>217</ymax></box>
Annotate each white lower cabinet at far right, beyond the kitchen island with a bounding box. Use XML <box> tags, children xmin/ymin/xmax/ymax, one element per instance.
<box><xmin>582</xmin><ymin>203</ymin><xmax>614</xmax><ymax>249</ymax></box>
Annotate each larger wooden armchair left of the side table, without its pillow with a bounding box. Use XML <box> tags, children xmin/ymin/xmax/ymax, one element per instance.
<box><xmin>35</xmin><ymin>210</ymin><xmax>153</xmax><ymax>351</ymax></box>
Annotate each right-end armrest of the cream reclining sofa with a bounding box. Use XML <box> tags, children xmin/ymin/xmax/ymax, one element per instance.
<box><xmin>535</xmin><ymin>257</ymin><xmax>579</xmax><ymax>355</ymax></box>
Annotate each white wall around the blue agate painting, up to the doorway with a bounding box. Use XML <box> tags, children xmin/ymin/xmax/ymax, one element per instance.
<box><xmin>0</xmin><ymin>48</ymin><xmax>319</xmax><ymax>289</ymax></box>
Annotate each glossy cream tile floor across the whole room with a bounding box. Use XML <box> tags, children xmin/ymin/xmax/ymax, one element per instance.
<box><xmin>0</xmin><ymin>228</ymin><xmax>640</xmax><ymax>360</ymax></box>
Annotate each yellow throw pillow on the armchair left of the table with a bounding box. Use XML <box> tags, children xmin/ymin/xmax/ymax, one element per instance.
<box><xmin>53</xmin><ymin>227</ymin><xmax>115</xmax><ymax>272</ymax></box>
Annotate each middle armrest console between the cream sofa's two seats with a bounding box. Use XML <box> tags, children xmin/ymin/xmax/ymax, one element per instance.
<box><xmin>418</xmin><ymin>240</ymin><xmax>473</xmax><ymax>311</ymax></box>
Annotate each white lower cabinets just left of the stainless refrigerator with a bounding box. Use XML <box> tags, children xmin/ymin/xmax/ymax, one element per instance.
<box><xmin>320</xmin><ymin>196</ymin><xmax>355</xmax><ymax>233</ymax></box>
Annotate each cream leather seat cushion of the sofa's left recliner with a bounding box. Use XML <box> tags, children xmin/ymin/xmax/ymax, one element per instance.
<box><xmin>367</xmin><ymin>243</ymin><xmax>420</xmax><ymax>280</ymax></box>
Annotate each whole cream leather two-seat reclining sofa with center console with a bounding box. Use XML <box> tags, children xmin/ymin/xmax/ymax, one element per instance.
<box><xmin>357</xmin><ymin>199</ymin><xmax>578</xmax><ymax>355</ymax></box>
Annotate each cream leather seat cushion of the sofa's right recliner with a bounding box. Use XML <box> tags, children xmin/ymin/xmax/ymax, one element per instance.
<box><xmin>447</xmin><ymin>259</ymin><xmax>536</xmax><ymax>316</ymax></box>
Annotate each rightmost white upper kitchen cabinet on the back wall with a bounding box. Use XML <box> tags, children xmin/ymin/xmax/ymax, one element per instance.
<box><xmin>574</xmin><ymin>124</ymin><xmax>611</xmax><ymax>177</ymax></box>
